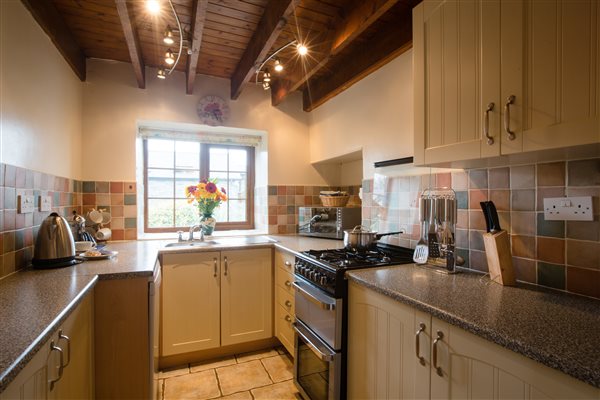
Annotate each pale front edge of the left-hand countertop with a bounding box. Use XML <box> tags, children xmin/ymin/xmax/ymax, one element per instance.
<box><xmin>0</xmin><ymin>275</ymin><xmax>98</xmax><ymax>393</ymax></box>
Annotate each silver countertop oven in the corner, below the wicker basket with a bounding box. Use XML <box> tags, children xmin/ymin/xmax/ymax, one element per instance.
<box><xmin>298</xmin><ymin>207</ymin><xmax>361</xmax><ymax>240</ymax></box>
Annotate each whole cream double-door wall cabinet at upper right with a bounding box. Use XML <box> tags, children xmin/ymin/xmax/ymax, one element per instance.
<box><xmin>413</xmin><ymin>0</ymin><xmax>600</xmax><ymax>164</ymax></box>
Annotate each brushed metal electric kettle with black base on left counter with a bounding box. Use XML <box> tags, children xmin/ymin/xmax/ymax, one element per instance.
<box><xmin>32</xmin><ymin>213</ymin><xmax>79</xmax><ymax>268</ymax></box>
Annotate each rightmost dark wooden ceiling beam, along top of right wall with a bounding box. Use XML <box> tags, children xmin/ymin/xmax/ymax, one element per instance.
<box><xmin>303</xmin><ymin>13</ymin><xmax>412</xmax><ymax>111</ymax></box>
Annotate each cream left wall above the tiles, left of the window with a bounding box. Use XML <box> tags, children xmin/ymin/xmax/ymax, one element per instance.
<box><xmin>0</xmin><ymin>0</ymin><xmax>82</xmax><ymax>179</ymax></box>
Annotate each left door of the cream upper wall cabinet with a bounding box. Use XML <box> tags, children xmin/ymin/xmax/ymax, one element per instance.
<box><xmin>413</xmin><ymin>0</ymin><xmax>500</xmax><ymax>164</ymax></box>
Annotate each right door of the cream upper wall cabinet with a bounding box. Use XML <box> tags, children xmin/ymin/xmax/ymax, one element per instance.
<box><xmin>501</xmin><ymin>0</ymin><xmax>600</xmax><ymax>154</ymax></box>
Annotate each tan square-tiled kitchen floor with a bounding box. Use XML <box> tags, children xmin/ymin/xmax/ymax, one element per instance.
<box><xmin>160</xmin><ymin>349</ymin><xmax>300</xmax><ymax>400</ymax></box>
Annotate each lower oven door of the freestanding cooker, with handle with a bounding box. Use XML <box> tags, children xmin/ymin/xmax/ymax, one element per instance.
<box><xmin>293</xmin><ymin>321</ymin><xmax>342</xmax><ymax>400</ymax></box>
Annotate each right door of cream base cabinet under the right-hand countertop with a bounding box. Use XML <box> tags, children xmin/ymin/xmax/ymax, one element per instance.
<box><xmin>431</xmin><ymin>318</ymin><xmax>600</xmax><ymax>399</ymax></box>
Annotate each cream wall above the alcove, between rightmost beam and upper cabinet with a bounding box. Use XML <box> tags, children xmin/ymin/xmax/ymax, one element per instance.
<box><xmin>309</xmin><ymin>50</ymin><xmax>413</xmax><ymax>179</ymax></box>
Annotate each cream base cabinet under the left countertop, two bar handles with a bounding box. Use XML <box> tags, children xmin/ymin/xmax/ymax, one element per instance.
<box><xmin>0</xmin><ymin>294</ymin><xmax>94</xmax><ymax>400</ymax></box>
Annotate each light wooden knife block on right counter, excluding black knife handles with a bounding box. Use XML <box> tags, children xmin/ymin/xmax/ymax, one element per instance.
<box><xmin>483</xmin><ymin>230</ymin><xmax>516</xmax><ymax>286</ymax></box>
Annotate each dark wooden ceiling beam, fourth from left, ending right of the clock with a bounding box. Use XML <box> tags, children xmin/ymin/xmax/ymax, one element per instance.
<box><xmin>231</xmin><ymin>0</ymin><xmax>298</xmax><ymax>100</ymax></box>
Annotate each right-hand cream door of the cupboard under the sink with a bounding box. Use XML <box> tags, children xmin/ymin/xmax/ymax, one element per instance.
<box><xmin>221</xmin><ymin>249</ymin><xmax>273</xmax><ymax>346</ymax></box>
